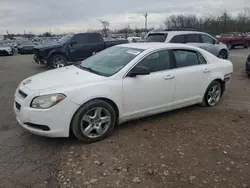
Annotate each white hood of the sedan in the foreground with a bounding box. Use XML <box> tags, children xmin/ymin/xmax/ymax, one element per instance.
<box><xmin>21</xmin><ymin>65</ymin><xmax>106</xmax><ymax>91</ymax></box>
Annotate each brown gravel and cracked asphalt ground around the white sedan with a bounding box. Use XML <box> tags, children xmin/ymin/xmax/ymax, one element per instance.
<box><xmin>0</xmin><ymin>49</ymin><xmax>250</xmax><ymax>188</ymax></box>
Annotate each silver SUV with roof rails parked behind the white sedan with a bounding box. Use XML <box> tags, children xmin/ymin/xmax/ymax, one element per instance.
<box><xmin>146</xmin><ymin>28</ymin><xmax>229</xmax><ymax>59</ymax></box>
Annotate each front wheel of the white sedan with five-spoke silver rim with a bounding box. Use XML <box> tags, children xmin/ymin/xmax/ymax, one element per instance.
<box><xmin>71</xmin><ymin>100</ymin><xmax>116</xmax><ymax>143</ymax></box>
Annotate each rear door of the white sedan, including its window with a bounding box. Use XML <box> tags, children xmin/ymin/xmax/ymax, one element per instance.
<box><xmin>173</xmin><ymin>49</ymin><xmax>211</xmax><ymax>107</ymax></box>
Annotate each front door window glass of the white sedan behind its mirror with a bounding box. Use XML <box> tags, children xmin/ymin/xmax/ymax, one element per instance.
<box><xmin>136</xmin><ymin>50</ymin><xmax>170</xmax><ymax>72</ymax></box>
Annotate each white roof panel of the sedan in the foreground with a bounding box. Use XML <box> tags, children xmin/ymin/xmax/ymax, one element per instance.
<box><xmin>118</xmin><ymin>42</ymin><xmax>200</xmax><ymax>50</ymax></box>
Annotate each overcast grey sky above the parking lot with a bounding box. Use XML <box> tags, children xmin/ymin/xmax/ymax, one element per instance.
<box><xmin>0</xmin><ymin>0</ymin><xmax>250</xmax><ymax>34</ymax></box>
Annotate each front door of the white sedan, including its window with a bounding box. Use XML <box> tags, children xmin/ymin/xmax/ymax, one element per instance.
<box><xmin>123</xmin><ymin>50</ymin><xmax>175</xmax><ymax>118</ymax></box>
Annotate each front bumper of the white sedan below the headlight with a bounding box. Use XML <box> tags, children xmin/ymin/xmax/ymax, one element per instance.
<box><xmin>13</xmin><ymin>84</ymin><xmax>79</xmax><ymax>137</ymax></box>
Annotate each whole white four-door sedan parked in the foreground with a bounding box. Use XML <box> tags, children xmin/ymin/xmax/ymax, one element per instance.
<box><xmin>14</xmin><ymin>43</ymin><xmax>233</xmax><ymax>143</ymax></box>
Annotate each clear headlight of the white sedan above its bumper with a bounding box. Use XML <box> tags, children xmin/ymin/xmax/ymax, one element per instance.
<box><xmin>30</xmin><ymin>93</ymin><xmax>66</xmax><ymax>109</ymax></box>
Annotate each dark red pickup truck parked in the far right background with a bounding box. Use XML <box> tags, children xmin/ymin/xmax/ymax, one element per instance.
<box><xmin>217</xmin><ymin>33</ymin><xmax>250</xmax><ymax>50</ymax></box>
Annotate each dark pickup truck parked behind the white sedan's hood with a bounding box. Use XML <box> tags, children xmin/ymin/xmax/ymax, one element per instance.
<box><xmin>34</xmin><ymin>33</ymin><xmax>128</xmax><ymax>68</ymax></box>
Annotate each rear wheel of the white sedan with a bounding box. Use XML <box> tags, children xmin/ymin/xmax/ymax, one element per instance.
<box><xmin>201</xmin><ymin>81</ymin><xmax>222</xmax><ymax>107</ymax></box>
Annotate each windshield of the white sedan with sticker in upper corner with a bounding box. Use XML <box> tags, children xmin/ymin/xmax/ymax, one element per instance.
<box><xmin>77</xmin><ymin>46</ymin><xmax>143</xmax><ymax>76</ymax></box>
